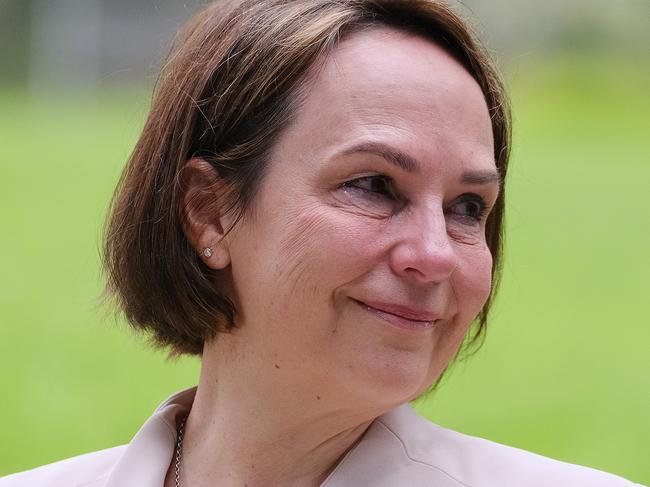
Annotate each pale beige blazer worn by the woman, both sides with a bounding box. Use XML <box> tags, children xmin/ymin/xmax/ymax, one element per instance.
<box><xmin>0</xmin><ymin>388</ymin><xmax>640</xmax><ymax>487</ymax></box>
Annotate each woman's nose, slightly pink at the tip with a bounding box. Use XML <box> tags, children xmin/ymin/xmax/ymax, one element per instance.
<box><xmin>390</xmin><ymin>208</ymin><xmax>458</xmax><ymax>284</ymax></box>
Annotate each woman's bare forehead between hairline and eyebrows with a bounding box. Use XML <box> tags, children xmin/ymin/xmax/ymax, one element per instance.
<box><xmin>278</xmin><ymin>28</ymin><xmax>494</xmax><ymax>173</ymax></box>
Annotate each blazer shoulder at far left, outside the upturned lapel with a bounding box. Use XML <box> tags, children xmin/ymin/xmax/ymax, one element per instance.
<box><xmin>0</xmin><ymin>446</ymin><xmax>126</xmax><ymax>487</ymax></box>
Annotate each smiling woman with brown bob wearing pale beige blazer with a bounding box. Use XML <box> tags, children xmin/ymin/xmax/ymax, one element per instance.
<box><xmin>0</xmin><ymin>0</ymin><xmax>632</xmax><ymax>487</ymax></box>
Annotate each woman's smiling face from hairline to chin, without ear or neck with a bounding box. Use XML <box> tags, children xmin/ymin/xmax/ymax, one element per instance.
<box><xmin>218</xmin><ymin>29</ymin><xmax>498</xmax><ymax>406</ymax></box>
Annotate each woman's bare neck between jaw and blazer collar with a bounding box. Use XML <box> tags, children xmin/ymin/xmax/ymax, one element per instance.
<box><xmin>168</xmin><ymin>335</ymin><xmax>384</xmax><ymax>487</ymax></box>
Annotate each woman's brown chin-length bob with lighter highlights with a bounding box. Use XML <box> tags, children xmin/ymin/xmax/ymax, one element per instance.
<box><xmin>103</xmin><ymin>0</ymin><xmax>510</xmax><ymax>356</ymax></box>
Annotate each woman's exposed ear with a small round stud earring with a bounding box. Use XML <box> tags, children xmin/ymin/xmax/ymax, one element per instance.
<box><xmin>181</xmin><ymin>158</ymin><xmax>230</xmax><ymax>269</ymax></box>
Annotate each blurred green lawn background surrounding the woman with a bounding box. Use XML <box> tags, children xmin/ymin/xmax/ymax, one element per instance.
<box><xmin>0</xmin><ymin>0</ymin><xmax>650</xmax><ymax>483</ymax></box>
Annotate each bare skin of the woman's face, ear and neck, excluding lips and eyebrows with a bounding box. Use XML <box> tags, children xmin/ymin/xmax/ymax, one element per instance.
<box><xmin>172</xmin><ymin>28</ymin><xmax>499</xmax><ymax>487</ymax></box>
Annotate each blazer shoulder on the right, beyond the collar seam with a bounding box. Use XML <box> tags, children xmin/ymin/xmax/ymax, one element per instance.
<box><xmin>375</xmin><ymin>405</ymin><xmax>635</xmax><ymax>487</ymax></box>
